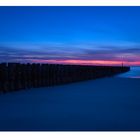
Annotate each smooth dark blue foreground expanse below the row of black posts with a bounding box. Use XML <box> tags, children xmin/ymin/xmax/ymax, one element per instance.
<box><xmin>0</xmin><ymin>78</ymin><xmax>140</xmax><ymax>131</ymax></box>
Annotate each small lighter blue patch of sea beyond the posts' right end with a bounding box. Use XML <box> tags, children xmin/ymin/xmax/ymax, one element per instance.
<box><xmin>117</xmin><ymin>66</ymin><xmax>140</xmax><ymax>78</ymax></box>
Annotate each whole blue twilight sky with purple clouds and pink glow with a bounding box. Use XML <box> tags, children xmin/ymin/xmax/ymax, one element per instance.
<box><xmin>0</xmin><ymin>6</ymin><xmax>140</xmax><ymax>66</ymax></box>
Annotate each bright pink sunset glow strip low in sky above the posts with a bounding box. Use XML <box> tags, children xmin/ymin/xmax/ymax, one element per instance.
<box><xmin>30</xmin><ymin>59</ymin><xmax>140</xmax><ymax>66</ymax></box>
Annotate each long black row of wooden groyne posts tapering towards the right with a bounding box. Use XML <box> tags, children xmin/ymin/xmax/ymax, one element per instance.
<box><xmin>0</xmin><ymin>63</ymin><xmax>130</xmax><ymax>93</ymax></box>
